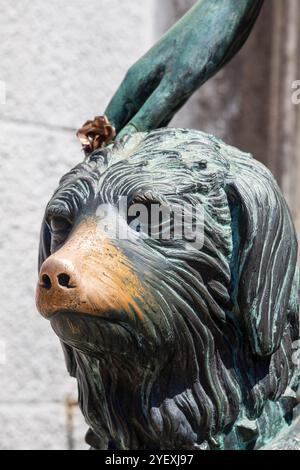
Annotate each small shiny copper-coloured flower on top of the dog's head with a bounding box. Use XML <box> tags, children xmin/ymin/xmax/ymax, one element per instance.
<box><xmin>76</xmin><ymin>116</ymin><xmax>116</xmax><ymax>153</ymax></box>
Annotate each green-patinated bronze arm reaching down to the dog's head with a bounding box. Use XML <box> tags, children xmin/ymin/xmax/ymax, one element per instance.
<box><xmin>105</xmin><ymin>0</ymin><xmax>263</xmax><ymax>137</ymax></box>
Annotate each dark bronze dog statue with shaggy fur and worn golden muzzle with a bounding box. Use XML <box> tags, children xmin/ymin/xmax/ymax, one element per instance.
<box><xmin>37</xmin><ymin>128</ymin><xmax>299</xmax><ymax>449</ymax></box>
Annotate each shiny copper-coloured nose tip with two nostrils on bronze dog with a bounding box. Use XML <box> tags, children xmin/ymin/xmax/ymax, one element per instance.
<box><xmin>39</xmin><ymin>258</ymin><xmax>77</xmax><ymax>291</ymax></box>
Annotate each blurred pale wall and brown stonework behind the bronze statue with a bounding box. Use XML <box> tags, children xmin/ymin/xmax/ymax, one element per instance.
<box><xmin>0</xmin><ymin>0</ymin><xmax>300</xmax><ymax>449</ymax></box>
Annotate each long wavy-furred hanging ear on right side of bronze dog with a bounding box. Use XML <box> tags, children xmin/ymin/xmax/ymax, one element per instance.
<box><xmin>233</xmin><ymin>158</ymin><xmax>297</xmax><ymax>356</ymax></box>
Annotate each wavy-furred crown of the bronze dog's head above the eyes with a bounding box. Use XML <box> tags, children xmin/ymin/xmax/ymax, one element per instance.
<box><xmin>52</xmin><ymin>128</ymin><xmax>230</xmax><ymax>209</ymax></box>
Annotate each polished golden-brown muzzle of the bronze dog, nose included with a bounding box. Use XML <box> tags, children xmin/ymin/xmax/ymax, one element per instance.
<box><xmin>36</xmin><ymin>218</ymin><xmax>144</xmax><ymax>319</ymax></box>
